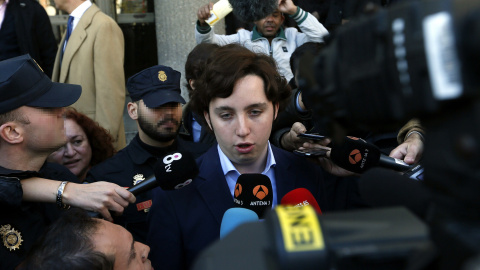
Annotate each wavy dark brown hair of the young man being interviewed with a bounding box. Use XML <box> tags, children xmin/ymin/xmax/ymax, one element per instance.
<box><xmin>189</xmin><ymin>44</ymin><xmax>291</xmax><ymax>130</ymax></box>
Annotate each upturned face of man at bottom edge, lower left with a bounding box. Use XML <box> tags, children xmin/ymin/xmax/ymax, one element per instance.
<box><xmin>92</xmin><ymin>219</ymin><xmax>153</xmax><ymax>270</ymax></box>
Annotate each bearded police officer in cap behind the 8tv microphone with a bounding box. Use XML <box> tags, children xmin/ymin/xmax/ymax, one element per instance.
<box><xmin>86</xmin><ymin>65</ymin><xmax>207</xmax><ymax>243</ymax></box>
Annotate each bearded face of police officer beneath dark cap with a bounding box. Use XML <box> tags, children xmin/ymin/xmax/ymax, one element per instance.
<box><xmin>137</xmin><ymin>100</ymin><xmax>182</xmax><ymax>142</ymax></box>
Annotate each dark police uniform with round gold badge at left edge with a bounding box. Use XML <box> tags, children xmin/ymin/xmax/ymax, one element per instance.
<box><xmin>0</xmin><ymin>163</ymin><xmax>78</xmax><ymax>270</ymax></box>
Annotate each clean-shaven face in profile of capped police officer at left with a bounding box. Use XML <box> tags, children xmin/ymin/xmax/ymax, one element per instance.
<box><xmin>18</xmin><ymin>106</ymin><xmax>67</xmax><ymax>152</ymax></box>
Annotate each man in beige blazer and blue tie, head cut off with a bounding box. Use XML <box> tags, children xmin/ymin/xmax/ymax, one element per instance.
<box><xmin>52</xmin><ymin>0</ymin><xmax>126</xmax><ymax>150</ymax></box>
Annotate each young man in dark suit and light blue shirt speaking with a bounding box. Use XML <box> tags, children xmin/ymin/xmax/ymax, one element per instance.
<box><xmin>147</xmin><ymin>44</ymin><xmax>348</xmax><ymax>269</ymax></box>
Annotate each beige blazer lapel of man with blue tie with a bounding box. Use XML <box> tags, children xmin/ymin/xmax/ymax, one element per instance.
<box><xmin>59</xmin><ymin>4</ymin><xmax>100</xmax><ymax>82</ymax></box>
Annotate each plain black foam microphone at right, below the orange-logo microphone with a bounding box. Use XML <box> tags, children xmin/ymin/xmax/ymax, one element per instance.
<box><xmin>358</xmin><ymin>168</ymin><xmax>432</xmax><ymax>217</ymax></box>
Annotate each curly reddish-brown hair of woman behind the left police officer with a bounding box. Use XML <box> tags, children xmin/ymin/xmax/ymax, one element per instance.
<box><xmin>65</xmin><ymin>107</ymin><xmax>116</xmax><ymax>167</ymax></box>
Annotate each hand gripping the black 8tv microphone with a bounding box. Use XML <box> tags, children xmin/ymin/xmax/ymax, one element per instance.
<box><xmin>63</xmin><ymin>182</ymin><xmax>136</xmax><ymax>221</ymax></box>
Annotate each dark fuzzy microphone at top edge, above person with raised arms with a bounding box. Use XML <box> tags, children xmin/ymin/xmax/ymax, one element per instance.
<box><xmin>229</xmin><ymin>0</ymin><xmax>278</xmax><ymax>22</ymax></box>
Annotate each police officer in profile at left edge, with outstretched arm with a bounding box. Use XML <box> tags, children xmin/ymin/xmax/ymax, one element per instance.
<box><xmin>0</xmin><ymin>55</ymin><xmax>135</xmax><ymax>269</ymax></box>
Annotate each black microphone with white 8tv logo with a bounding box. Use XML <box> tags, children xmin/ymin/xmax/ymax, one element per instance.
<box><xmin>127</xmin><ymin>151</ymin><xmax>198</xmax><ymax>193</ymax></box>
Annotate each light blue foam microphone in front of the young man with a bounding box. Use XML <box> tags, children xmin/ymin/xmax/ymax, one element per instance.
<box><xmin>220</xmin><ymin>207</ymin><xmax>258</xmax><ymax>239</ymax></box>
